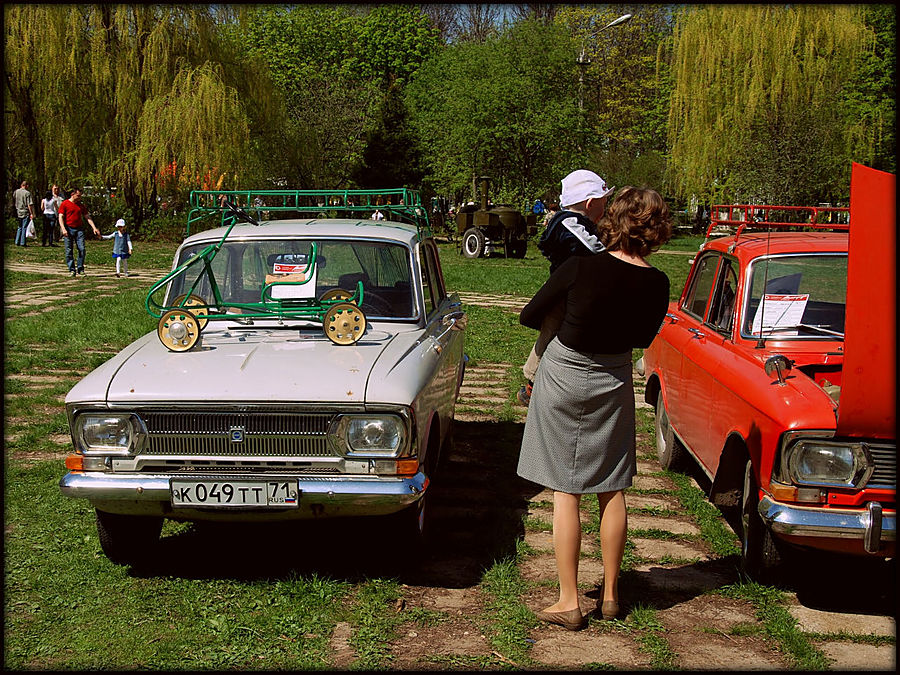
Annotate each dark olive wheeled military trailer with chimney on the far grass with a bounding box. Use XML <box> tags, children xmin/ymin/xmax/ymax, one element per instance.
<box><xmin>456</xmin><ymin>176</ymin><xmax>537</xmax><ymax>258</ymax></box>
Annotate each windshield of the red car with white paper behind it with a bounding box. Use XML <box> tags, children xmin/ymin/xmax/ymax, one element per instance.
<box><xmin>741</xmin><ymin>254</ymin><xmax>847</xmax><ymax>339</ymax></box>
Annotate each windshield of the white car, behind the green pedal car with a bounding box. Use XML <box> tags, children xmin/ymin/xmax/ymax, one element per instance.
<box><xmin>169</xmin><ymin>239</ymin><xmax>416</xmax><ymax>319</ymax></box>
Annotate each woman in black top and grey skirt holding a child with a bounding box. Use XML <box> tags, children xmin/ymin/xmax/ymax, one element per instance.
<box><xmin>518</xmin><ymin>187</ymin><xmax>672</xmax><ymax>630</ymax></box>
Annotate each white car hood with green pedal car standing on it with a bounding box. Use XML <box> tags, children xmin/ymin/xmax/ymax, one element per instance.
<box><xmin>94</xmin><ymin>327</ymin><xmax>394</xmax><ymax>403</ymax></box>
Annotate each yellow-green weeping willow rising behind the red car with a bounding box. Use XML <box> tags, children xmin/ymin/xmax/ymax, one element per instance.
<box><xmin>668</xmin><ymin>5</ymin><xmax>874</xmax><ymax>203</ymax></box>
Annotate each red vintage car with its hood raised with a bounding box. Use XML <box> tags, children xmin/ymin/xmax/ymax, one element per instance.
<box><xmin>638</xmin><ymin>164</ymin><xmax>897</xmax><ymax>580</ymax></box>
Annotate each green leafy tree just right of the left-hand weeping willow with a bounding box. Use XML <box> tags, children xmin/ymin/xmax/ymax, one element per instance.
<box><xmin>239</xmin><ymin>5</ymin><xmax>440</xmax><ymax>187</ymax></box>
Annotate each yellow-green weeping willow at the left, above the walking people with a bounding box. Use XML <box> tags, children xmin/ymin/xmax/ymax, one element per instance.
<box><xmin>4</xmin><ymin>4</ymin><xmax>277</xmax><ymax>222</ymax></box>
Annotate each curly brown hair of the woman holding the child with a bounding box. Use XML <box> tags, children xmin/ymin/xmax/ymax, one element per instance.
<box><xmin>599</xmin><ymin>185</ymin><xmax>672</xmax><ymax>258</ymax></box>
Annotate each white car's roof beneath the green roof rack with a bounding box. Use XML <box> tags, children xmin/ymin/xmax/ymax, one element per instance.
<box><xmin>182</xmin><ymin>218</ymin><xmax>420</xmax><ymax>246</ymax></box>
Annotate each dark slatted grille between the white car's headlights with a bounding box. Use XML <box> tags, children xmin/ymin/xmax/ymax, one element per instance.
<box><xmin>141</xmin><ymin>411</ymin><xmax>334</xmax><ymax>457</ymax></box>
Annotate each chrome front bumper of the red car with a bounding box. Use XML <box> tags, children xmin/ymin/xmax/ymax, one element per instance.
<box><xmin>759</xmin><ymin>495</ymin><xmax>897</xmax><ymax>553</ymax></box>
